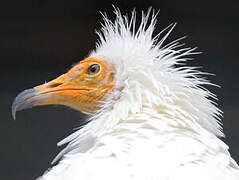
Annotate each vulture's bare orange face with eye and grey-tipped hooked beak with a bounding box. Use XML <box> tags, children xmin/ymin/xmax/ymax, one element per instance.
<box><xmin>12</xmin><ymin>58</ymin><xmax>115</xmax><ymax>117</ymax></box>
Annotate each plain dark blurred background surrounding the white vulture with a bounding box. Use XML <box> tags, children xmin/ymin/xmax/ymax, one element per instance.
<box><xmin>0</xmin><ymin>0</ymin><xmax>239</xmax><ymax>180</ymax></box>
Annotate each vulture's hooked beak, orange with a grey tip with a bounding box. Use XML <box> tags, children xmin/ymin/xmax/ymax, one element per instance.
<box><xmin>12</xmin><ymin>74</ymin><xmax>91</xmax><ymax>119</ymax></box>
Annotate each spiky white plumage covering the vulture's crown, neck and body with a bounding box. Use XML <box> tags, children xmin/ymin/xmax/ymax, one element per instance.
<box><xmin>36</xmin><ymin>9</ymin><xmax>239</xmax><ymax>180</ymax></box>
